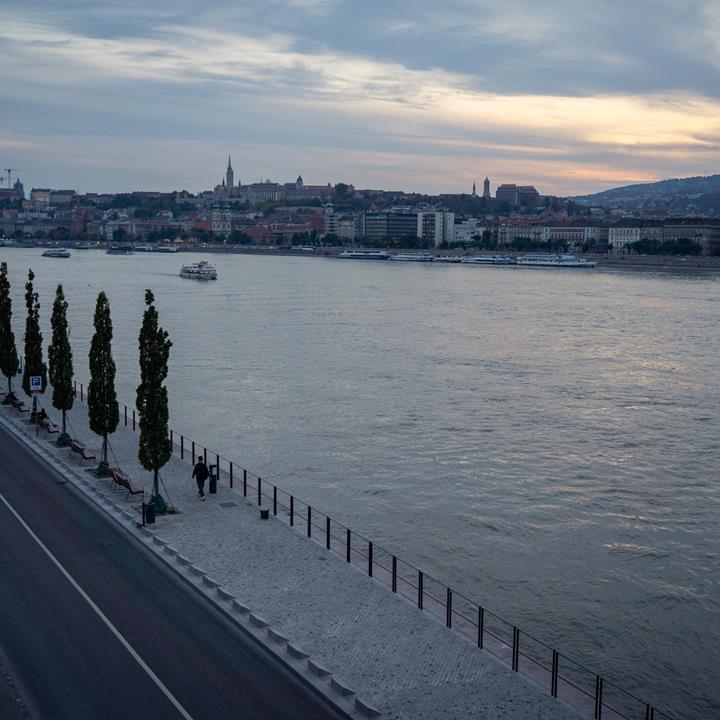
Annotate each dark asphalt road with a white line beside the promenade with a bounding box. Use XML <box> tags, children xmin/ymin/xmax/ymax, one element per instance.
<box><xmin>0</xmin><ymin>426</ymin><xmax>345</xmax><ymax>720</ymax></box>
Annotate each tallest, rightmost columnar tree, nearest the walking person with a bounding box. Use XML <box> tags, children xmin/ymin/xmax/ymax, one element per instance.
<box><xmin>136</xmin><ymin>290</ymin><xmax>172</xmax><ymax>513</ymax></box>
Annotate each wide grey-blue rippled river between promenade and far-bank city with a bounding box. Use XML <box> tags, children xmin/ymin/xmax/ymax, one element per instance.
<box><xmin>0</xmin><ymin>249</ymin><xmax>720</xmax><ymax>718</ymax></box>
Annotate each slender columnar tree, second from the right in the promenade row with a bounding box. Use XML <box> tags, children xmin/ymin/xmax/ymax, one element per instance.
<box><xmin>88</xmin><ymin>292</ymin><xmax>120</xmax><ymax>474</ymax></box>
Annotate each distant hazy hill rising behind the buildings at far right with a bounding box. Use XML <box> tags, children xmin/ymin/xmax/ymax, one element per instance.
<box><xmin>571</xmin><ymin>175</ymin><xmax>720</xmax><ymax>215</ymax></box>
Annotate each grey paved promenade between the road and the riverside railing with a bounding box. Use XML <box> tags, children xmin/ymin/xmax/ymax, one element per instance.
<box><xmin>0</xmin><ymin>395</ymin><xmax>581</xmax><ymax>720</ymax></box>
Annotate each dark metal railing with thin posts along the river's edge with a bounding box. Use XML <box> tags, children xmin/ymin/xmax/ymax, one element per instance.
<box><xmin>75</xmin><ymin>376</ymin><xmax>675</xmax><ymax>720</ymax></box>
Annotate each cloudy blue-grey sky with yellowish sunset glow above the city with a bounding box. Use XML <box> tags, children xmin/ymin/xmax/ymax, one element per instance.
<box><xmin>0</xmin><ymin>0</ymin><xmax>720</xmax><ymax>195</ymax></box>
